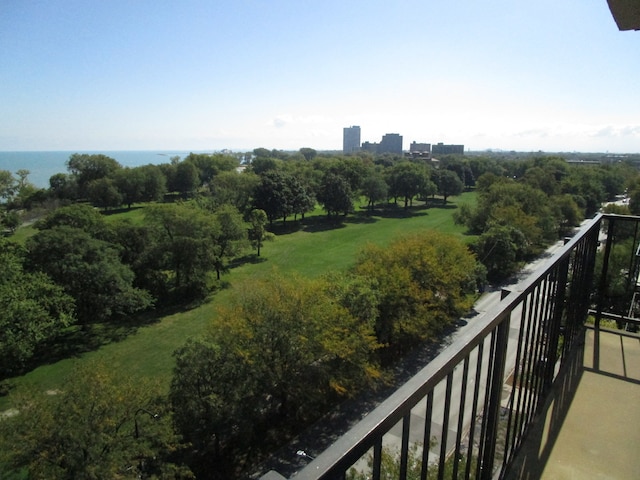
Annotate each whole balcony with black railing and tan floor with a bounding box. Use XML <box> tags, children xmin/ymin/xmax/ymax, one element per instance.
<box><xmin>260</xmin><ymin>215</ymin><xmax>640</xmax><ymax>480</ymax></box>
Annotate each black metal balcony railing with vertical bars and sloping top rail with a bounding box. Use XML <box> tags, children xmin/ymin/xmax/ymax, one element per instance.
<box><xmin>262</xmin><ymin>215</ymin><xmax>640</xmax><ymax>480</ymax></box>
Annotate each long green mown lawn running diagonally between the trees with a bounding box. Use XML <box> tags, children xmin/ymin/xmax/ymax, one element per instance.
<box><xmin>0</xmin><ymin>193</ymin><xmax>475</xmax><ymax>411</ymax></box>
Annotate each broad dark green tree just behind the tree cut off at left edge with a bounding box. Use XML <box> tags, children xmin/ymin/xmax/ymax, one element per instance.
<box><xmin>27</xmin><ymin>226</ymin><xmax>152</xmax><ymax>323</ymax></box>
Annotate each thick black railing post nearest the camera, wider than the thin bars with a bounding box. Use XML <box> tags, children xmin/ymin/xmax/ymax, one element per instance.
<box><xmin>480</xmin><ymin>289</ymin><xmax>511</xmax><ymax>480</ymax></box>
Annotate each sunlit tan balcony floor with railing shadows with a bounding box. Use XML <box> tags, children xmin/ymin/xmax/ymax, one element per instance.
<box><xmin>507</xmin><ymin>329</ymin><xmax>640</xmax><ymax>480</ymax></box>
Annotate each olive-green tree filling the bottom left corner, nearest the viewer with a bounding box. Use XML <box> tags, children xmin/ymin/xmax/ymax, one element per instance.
<box><xmin>0</xmin><ymin>364</ymin><xmax>193</xmax><ymax>480</ymax></box>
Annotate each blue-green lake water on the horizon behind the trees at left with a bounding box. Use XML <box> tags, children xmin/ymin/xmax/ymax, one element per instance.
<box><xmin>0</xmin><ymin>150</ymin><xmax>198</xmax><ymax>188</ymax></box>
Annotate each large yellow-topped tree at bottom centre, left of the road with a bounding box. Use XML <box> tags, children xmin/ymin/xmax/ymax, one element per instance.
<box><xmin>170</xmin><ymin>274</ymin><xmax>379</xmax><ymax>478</ymax></box>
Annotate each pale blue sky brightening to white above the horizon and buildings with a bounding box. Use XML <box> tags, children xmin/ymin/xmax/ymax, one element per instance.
<box><xmin>0</xmin><ymin>0</ymin><xmax>640</xmax><ymax>153</ymax></box>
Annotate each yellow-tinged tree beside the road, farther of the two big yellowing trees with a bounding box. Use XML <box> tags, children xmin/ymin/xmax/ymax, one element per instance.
<box><xmin>353</xmin><ymin>231</ymin><xmax>476</xmax><ymax>353</ymax></box>
